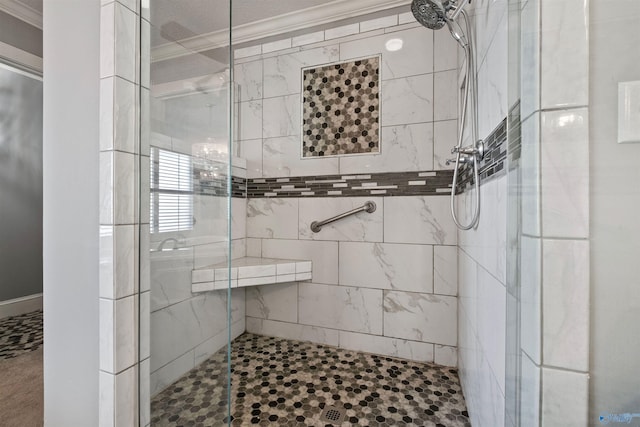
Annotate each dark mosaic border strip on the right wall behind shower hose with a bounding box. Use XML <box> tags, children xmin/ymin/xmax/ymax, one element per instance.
<box><xmin>456</xmin><ymin>117</ymin><xmax>507</xmax><ymax>194</ymax></box>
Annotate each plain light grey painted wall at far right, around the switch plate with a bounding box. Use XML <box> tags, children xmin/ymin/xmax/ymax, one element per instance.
<box><xmin>589</xmin><ymin>0</ymin><xmax>640</xmax><ymax>423</ymax></box>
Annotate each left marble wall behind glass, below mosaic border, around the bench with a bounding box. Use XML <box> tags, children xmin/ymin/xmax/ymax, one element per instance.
<box><xmin>144</xmin><ymin>161</ymin><xmax>247</xmax><ymax>404</ymax></box>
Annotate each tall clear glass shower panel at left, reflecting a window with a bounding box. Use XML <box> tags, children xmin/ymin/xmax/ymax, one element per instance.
<box><xmin>140</xmin><ymin>0</ymin><xmax>234</xmax><ymax>426</ymax></box>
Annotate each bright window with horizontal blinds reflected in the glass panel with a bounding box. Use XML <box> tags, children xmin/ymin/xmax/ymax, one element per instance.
<box><xmin>151</xmin><ymin>147</ymin><xmax>193</xmax><ymax>233</ymax></box>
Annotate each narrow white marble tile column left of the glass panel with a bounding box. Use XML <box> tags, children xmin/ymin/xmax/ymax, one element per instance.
<box><xmin>99</xmin><ymin>0</ymin><xmax>142</xmax><ymax>427</ymax></box>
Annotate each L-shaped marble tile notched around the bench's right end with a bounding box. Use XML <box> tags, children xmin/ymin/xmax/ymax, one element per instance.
<box><xmin>262</xmin><ymin>239</ymin><xmax>338</xmax><ymax>284</ymax></box>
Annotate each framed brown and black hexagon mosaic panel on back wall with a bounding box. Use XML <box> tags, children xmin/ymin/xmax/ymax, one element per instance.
<box><xmin>302</xmin><ymin>56</ymin><xmax>380</xmax><ymax>158</ymax></box>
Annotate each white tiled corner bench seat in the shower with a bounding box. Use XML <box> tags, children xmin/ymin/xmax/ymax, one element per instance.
<box><xmin>191</xmin><ymin>257</ymin><xmax>311</xmax><ymax>292</ymax></box>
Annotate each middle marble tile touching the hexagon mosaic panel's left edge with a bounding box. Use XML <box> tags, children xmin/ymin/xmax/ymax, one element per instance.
<box><xmin>262</xmin><ymin>95</ymin><xmax>302</xmax><ymax>139</ymax></box>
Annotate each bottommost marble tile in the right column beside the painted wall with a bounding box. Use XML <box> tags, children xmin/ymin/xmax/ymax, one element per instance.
<box><xmin>541</xmin><ymin>368</ymin><xmax>595</xmax><ymax>427</ymax></box>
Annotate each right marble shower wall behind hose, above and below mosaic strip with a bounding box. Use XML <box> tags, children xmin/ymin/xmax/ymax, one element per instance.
<box><xmin>457</xmin><ymin>0</ymin><xmax>509</xmax><ymax>427</ymax></box>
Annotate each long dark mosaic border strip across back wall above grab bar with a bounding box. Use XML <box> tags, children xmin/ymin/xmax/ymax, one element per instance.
<box><xmin>247</xmin><ymin>170</ymin><xmax>453</xmax><ymax>198</ymax></box>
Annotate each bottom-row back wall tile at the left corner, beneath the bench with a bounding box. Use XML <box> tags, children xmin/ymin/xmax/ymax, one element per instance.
<box><xmin>247</xmin><ymin>317</ymin><xmax>339</xmax><ymax>347</ymax></box>
